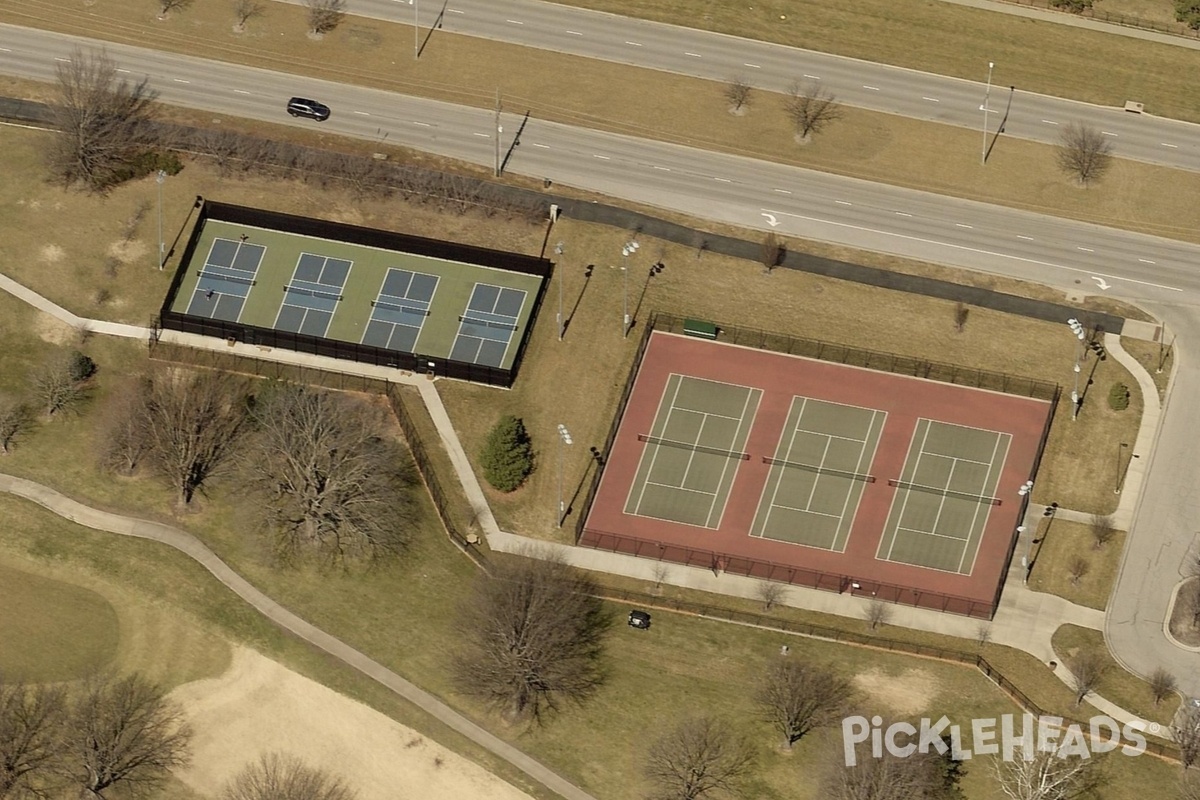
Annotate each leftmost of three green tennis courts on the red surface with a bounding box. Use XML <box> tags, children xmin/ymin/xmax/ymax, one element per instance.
<box><xmin>625</xmin><ymin>374</ymin><xmax>762</xmax><ymax>529</ymax></box>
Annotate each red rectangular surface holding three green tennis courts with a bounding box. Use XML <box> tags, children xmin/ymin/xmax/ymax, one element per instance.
<box><xmin>580</xmin><ymin>331</ymin><xmax>1054</xmax><ymax>618</ymax></box>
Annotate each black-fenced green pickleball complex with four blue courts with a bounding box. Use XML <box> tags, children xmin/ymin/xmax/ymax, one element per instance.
<box><xmin>160</xmin><ymin>200</ymin><xmax>551</xmax><ymax>386</ymax></box>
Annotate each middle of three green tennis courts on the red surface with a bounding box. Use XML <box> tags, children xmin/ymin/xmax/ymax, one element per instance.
<box><xmin>750</xmin><ymin>397</ymin><xmax>887</xmax><ymax>553</ymax></box>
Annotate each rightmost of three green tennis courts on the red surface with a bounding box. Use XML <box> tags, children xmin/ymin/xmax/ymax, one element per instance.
<box><xmin>878</xmin><ymin>419</ymin><xmax>1013</xmax><ymax>575</ymax></box>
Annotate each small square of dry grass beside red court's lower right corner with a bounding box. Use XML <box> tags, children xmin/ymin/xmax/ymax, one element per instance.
<box><xmin>1030</xmin><ymin>517</ymin><xmax>1126</xmax><ymax>610</ymax></box>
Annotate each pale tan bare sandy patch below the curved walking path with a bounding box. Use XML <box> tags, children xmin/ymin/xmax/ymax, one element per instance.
<box><xmin>172</xmin><ymin>648</ymin><xmax>529</xmax><ymax>800</ymax></box>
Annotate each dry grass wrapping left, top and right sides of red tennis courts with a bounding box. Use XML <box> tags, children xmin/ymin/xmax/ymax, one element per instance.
<box><xmin>437</xmin><ymin>219</ymin><xmax>1141</xmax><ymax>536</ymax></box>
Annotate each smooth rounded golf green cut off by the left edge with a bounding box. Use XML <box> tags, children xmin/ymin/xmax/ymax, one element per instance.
<box><xmin>0</xmin><ymin>563</ymin><xmax>119</xmax><ymax>682</ymax></box>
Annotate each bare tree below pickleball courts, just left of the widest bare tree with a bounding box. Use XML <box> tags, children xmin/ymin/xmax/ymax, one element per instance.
<box><xmin>143</xmin><ymin>368</ymin><xmax>247</xmax><ymax>507</ymax></box>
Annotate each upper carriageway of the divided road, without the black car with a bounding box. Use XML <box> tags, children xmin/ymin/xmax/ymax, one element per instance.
<box><xmin>272</xmin><ymin>0</ymin><xmax>1200</xmax><ymax>170</ymax></box>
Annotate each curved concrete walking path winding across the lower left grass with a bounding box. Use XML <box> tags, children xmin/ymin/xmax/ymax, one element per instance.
<box><xmin>0</xmin><ymin>474</ymin><xmax>595</xmax><ymax>800</ymax></box>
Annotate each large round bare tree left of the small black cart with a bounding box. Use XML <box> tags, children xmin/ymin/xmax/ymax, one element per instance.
<box><xmin>455</xmin><ymin>553</ymin><xmax>612</xmax><ymax>721</ymax></box>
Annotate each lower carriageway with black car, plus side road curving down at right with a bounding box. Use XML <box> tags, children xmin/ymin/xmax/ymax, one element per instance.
<box><xmin>0</xmin><ymin>18</ymin><xmax>1200</xmax><ymax>694</ymax></box>
